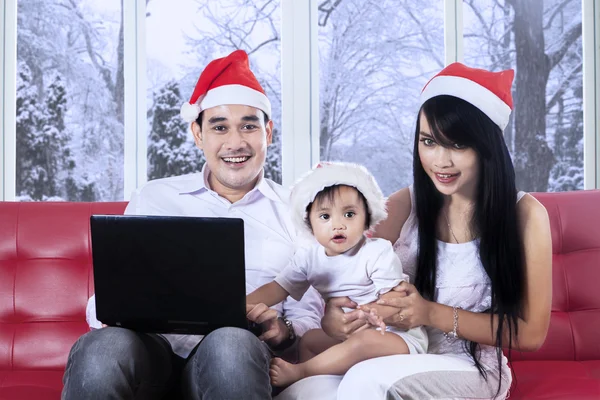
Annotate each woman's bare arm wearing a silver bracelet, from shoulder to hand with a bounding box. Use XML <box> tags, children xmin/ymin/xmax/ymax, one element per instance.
<box><xmin>383</xmin><ymin>195</ymin><xmax>552</xmax><ymax>351</ymax></box>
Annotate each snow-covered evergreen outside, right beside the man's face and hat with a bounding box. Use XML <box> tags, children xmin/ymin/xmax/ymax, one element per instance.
<box><xmin>148</xmin><ymin>81</ymin><xmax>205</xmax><ymax>180</ymax></box>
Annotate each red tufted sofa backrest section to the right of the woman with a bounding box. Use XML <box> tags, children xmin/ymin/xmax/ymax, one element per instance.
<box><xmin>513</xmin><ymin>190</ymin><xmax>600</xmax><ymax>361</ymax></box>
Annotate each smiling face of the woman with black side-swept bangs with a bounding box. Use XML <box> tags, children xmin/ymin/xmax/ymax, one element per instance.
<box><xmin>418</xmin><ymin>112</ymin><xmax>479</xmax><ymax>197</ymax></box>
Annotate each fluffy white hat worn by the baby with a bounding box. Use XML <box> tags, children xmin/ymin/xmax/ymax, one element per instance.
<box><xmin>290</xmin><ymin>162</ymin><xmax>387</xmax><ymax>234</ymax></box>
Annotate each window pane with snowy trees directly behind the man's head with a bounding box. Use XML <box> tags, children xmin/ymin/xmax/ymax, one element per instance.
<box><xmin>146</xmin><ymin>0</ymin><xmax>281</xmax><ymax>182</ymax></box>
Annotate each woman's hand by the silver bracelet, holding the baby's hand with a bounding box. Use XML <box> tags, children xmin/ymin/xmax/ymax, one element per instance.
<box><xmin>377</xmin><ymin>282</ymin><xmax>433</xmax><ymax>329</ymax></box>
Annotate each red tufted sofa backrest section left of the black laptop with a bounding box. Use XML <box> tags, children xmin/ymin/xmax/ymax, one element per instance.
<box><xmin>0</xmin><ymin>202</ymin><xmax>127</xmax><ymax>370</ymax></box>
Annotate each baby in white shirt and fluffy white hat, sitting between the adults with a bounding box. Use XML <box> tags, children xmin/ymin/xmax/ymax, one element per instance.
<box><xmin>246</xmin><ymin>163</ymin><xmax>428</xmax><ymax>386</ymax></box>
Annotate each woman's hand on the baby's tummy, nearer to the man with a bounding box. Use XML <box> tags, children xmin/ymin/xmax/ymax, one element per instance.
<box><xmin>321</xmin><ymin>297</ymin><xmax>370</xmax><ymax>341</ymax></box>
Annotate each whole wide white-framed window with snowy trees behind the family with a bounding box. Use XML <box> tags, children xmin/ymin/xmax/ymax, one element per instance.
<box><xmin>0</xmin><ymin>0</ymin><xmax>600</xmax><ymax>201</ymax></box>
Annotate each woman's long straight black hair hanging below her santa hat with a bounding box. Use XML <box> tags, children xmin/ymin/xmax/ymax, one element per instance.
<box><xmin>413</xmin><ymin>96</ymin><xmax>525</xmax><ymax>394</ymax></box>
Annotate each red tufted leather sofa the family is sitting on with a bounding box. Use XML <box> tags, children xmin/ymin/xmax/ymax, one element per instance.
<box><xmin>0</xmin><ymin>191</ymin><xmax>600</xmax><ymax>400</ymax></box>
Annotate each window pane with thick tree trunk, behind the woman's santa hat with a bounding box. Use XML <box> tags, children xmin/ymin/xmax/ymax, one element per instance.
<box><xmin>463</xmin><ymin>0</ymin><xmax>584</xmax><ymax>191</ymax></box>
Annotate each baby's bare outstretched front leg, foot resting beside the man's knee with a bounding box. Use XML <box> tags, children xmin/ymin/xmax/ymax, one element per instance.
<box><xmin>270</xmin><ymin>329</ymin><xmax>410</xmax><ymax>386</ymax></box>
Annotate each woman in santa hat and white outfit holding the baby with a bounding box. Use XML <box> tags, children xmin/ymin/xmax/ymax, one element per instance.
<box><xmin>274</xmin><ymin>63</ymin><xmax>552</xmax><ymax>399</ymax></box>
